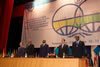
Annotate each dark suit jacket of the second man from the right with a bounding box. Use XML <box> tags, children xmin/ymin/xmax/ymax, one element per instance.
<box><xmin>58</xmin><ymin>44</ymin><xmax>68</xmax><ymax>57</ymax></box>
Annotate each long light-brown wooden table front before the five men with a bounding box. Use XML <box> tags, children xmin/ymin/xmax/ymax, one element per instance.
<box><xmin>0</xmin><ymin>58</ymin><xmax>86</xmax><ymax>67</ymax></box>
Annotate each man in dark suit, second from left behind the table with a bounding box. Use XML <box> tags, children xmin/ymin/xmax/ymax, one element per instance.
<box><xmin>26</xmin><ymin>40</ymin><xmax>35</xmax><ymax>57</ymax></box>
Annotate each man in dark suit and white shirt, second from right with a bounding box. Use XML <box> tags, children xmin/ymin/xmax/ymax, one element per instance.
<box><xmin>58</xmin><ymin>38</ymin><xmax>68</xmax><ymax>57</ymax></box>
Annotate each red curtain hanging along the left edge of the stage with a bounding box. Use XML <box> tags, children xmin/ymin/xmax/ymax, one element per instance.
<box><xmin>0</xmin><ymin>0</ymin><xmax>14</xmax><ymax>52</ymax></box>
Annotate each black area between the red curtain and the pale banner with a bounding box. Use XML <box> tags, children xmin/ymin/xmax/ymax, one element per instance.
<box><xmin>7</xmin><ymin>17</ymin><xmax>23</xmax><ymax>49</ymax></box>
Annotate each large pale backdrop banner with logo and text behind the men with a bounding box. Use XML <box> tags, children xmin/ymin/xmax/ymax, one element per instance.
<box><xmin>22</xmin><ymin>0</ymin><xmax>100</xmax><ymax>47</ymax></box>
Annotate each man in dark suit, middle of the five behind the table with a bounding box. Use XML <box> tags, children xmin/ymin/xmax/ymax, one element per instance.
<box><xmin>40</xmin><ymin>40</ymin><xmax>49</xmax><ymax>57</ymax></box>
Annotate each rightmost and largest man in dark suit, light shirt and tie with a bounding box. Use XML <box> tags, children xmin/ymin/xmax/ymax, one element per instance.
<box><xmin>72</xmin><ymin>36</ymin><xmax>85</xmax><ymax>58</ymax></box>
